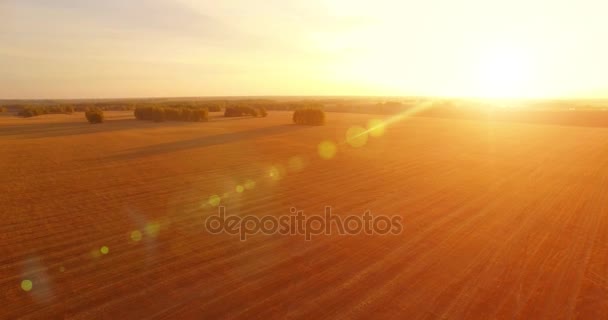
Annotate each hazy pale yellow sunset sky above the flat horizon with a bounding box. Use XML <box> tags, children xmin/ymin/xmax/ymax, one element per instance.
<box><xmin>0</xmin><ymin>0</ymin><xmax>608</xmax><ymax>99</ymax></box>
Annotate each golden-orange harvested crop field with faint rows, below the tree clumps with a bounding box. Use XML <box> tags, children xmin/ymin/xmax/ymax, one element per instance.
<box><xmin>0</xmin><ymin>111</ymin><xmax>608</xmax><ymax>319</ymax></box>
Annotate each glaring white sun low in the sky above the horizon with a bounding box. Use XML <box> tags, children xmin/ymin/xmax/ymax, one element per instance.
<box><xmin>474</xmin><ymin>46</ymin><xmax>533</xmax><ymax>98</ymax></box>
